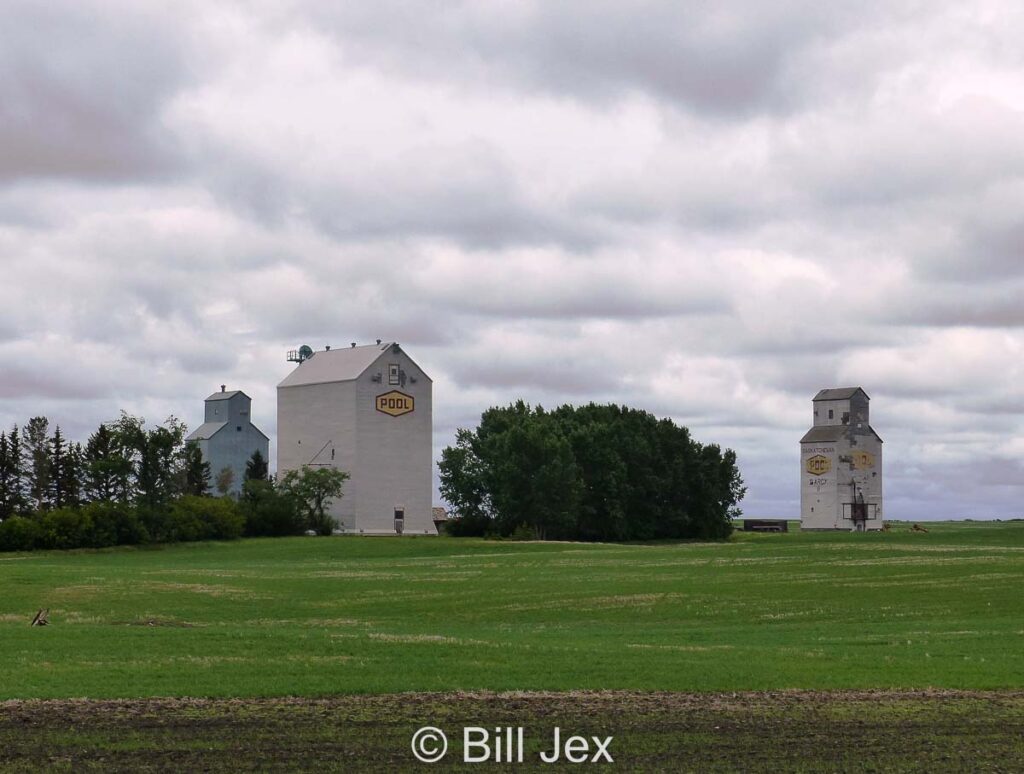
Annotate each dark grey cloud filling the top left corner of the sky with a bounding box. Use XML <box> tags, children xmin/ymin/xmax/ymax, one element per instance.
<box><xmin>0</xmin><ymin>1</ymin><xmax>187</xmax><ymax>180</ymax></box>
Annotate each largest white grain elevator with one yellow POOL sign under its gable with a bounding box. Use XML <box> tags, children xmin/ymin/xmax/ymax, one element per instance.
<box><xmin>278</xmin><ymin>341</ymin><xmax>437</xmax><ymax>534</ymax></box>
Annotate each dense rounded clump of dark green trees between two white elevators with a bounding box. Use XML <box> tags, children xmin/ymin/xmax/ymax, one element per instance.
<box><xmin>439</xmin><ymin>400</ymin><xmax>745</xmax><ymax>541</ymax></box>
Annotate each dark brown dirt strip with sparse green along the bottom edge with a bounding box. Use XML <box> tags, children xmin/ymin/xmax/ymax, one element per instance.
<box><xmin>0</xmin><ymin>691</ymin><xmax>1024</xmax><ymax>772</ymax></box>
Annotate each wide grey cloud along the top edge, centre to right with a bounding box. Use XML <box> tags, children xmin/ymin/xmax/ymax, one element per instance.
<box><xmin>309</xmin><ymin>0</ymin><xmax>888</xmax><ymax>116</ymax></box>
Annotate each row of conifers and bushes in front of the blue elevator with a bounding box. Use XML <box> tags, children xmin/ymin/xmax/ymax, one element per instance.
<box><xmin>0</xmin><ymin>412</ymin><xmax>348</xmax><ymax>551</ymax></box>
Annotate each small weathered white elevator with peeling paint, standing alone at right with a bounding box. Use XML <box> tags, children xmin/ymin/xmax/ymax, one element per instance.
<box><xmin>800</xmin><ymin>387</ymin><xmax>883</xmax><ymax>531</ymax></box>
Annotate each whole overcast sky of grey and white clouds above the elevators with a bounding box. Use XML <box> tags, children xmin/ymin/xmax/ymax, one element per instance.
<box><xmin>0</xmin><ymin>0</ymin><xmax>1024</xmax><ymax>520</ymax></box>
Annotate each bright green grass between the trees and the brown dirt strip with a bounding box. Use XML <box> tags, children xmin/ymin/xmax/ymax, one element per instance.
<box><xmin>0</xmin><ymin>522</ymin><xmax>1024</xmax><ymax>698</ymax></box>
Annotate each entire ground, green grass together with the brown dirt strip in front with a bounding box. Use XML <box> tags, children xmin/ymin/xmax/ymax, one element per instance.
<box><xmin>0</xmin><ymin>522</ymin><xmax>1024</xmax><ymax>772</ymax></box>
